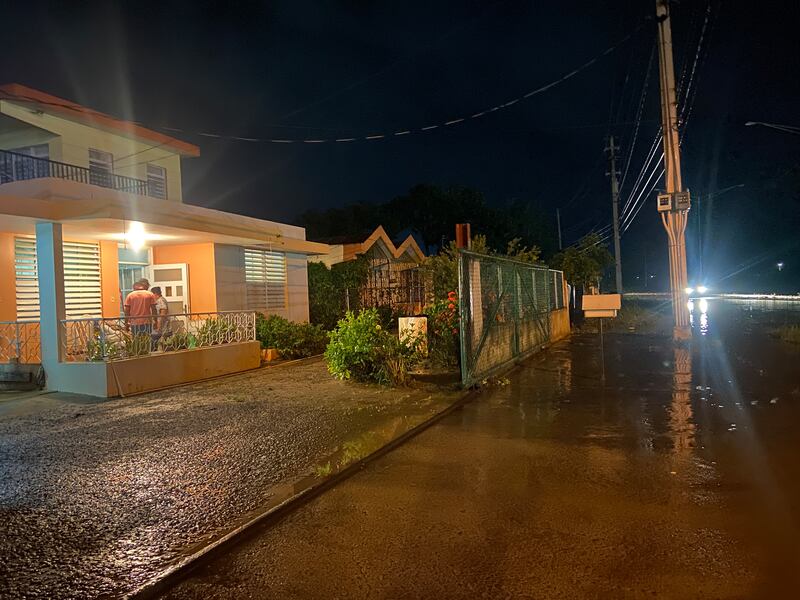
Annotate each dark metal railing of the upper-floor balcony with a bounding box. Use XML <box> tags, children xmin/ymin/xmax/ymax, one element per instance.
<box><xmin>0</xmin><ymin>150</ymin><xmax>153</xmax><ymax>197</ymax></box>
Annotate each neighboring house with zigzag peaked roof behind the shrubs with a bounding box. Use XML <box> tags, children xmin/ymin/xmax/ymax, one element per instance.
<box><xmin>311</xmin><ymin>226</ymin><xmax>425</xmax><ymax>314</ymax></box>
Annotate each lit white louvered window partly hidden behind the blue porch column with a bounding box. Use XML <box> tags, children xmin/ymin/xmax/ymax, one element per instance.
<box><xmin>14</xmin><ymin>237</ymin><xmax>102</xmax><ymax>321</ymax></box>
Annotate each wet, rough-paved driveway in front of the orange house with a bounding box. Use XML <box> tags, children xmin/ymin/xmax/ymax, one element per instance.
<box><xmin>0</xmin><ymin>359</ymin><xmax>460</xmax><ymax>598</ymax></box>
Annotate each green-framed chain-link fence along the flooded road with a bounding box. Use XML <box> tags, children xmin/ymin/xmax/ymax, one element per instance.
<box><xmin>458</xmin><ymin>251</ymin><xmax>564</xmax><ymax>386</ymax></box>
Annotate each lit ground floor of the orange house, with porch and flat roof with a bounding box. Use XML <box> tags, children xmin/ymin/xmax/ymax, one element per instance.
<box><xmin>0</xmin><ymin>179</ymin><xmax>326</xmax><ymax>397</ymax></box>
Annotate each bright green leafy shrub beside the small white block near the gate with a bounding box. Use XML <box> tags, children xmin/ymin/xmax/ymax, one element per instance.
<box><xmin>325</xmin><ymin>308</ymin><xmax>417</xmax><ymax>385</ymax></box>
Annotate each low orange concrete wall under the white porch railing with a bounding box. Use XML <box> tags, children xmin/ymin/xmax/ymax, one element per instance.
<box><xmin>103</xmin><ymin>342</ymin><xmax>261</xmax><ymax>397</ymax></box>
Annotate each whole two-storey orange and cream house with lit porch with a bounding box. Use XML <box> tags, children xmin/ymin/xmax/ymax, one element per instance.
<box><xmin>0</xmin><ymin>84</ymin><xmax>329</xmax><ymax>396</ymax></box>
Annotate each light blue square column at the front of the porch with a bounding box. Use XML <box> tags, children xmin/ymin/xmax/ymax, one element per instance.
<box><xmin>36</xmin><ymin>223</ymin><xmax>66</xmax><ymax>370</ymax></box>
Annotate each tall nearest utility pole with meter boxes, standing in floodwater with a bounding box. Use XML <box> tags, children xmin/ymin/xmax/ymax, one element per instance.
<box><xmin>656</xmin><ymin>0</ymin><xmax>692</xmax><ymax>340</ymax></box>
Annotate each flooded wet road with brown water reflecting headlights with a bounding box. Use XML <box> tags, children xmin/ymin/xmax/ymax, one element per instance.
<box><xmin>168</xmin><ymin>302</ymin><xmax>800</xmax><ymax>600</ymax></box>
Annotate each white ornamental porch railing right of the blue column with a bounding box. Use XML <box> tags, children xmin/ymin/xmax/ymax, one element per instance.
<box><xmin>61</xmin><ymin>311</ymin><xmax>256</xmax><ymax>362</ymax></box>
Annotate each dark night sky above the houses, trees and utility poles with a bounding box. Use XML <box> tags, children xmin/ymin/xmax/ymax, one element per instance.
<box><xmin>0</xmin><ymin>0</ymin><xmax>800</xmax><ymax>291</ymax></box>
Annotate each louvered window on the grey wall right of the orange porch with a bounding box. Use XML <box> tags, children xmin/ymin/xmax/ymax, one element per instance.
<box><xmin>244</xmin><ymin>248</ymin><xmax>286</xmax><ymax>312</ymax></box>
